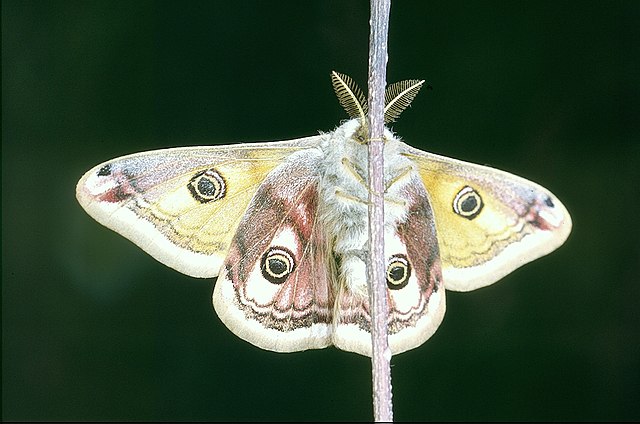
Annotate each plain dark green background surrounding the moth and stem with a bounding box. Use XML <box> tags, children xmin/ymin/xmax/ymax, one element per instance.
<box><xmin>2</xmin><ymin>1</ymin><xmax>640</xmax><ymax>421</ymax></box>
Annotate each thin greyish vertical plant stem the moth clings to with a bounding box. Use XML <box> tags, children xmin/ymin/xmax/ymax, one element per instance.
<box><xmin>368</xmin><ymin>0</ymin><xmax>393</xmax><ymax>422</ymax></box>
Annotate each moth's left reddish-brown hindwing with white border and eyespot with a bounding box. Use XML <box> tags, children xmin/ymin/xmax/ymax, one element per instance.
<box><xmin>213</xmin><ymin>150</ymin><xmax>333</xmax><ymax>352</ymax></box>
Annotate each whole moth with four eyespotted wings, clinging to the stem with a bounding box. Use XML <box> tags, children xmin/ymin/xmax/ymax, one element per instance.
<box><xmin>76</xmin><ymin>72</ymin><xmax>571</xmax><ymax>356</ymax></box>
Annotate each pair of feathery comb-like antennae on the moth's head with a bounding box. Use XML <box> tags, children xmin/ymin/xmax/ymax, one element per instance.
<box><xmin>331</xmin><ymin>71</ymin><xmax>424</xmax><ymax>124</ymax></box>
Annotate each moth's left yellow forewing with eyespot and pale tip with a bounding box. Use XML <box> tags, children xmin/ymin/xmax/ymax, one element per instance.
<box><xmin>76</xmin><ymin>136</ymin><xmax>320</xmax><ymax>277</ymax></box>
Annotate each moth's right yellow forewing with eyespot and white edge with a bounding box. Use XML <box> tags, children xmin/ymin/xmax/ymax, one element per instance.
<box><xmin>404</xmin><ymin>145</ymin><xmax>571</xmax><ymax>291</ymax></box>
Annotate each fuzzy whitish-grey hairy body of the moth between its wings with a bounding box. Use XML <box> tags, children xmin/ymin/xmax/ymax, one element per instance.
<box><xmin>318</xmin><ymin>119</ymin><xmax>416</xmax><ymax>296</ymax></box>
